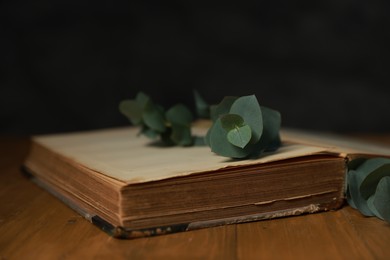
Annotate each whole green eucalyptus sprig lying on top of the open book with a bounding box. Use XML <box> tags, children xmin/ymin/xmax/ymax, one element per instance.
<box><xmin>119</xmin><ymin>91</ymin><xmax>281</xmax><ymax>158</ymax></box>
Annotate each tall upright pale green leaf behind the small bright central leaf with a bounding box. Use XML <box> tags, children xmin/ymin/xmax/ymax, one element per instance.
<box><xmin>229</xmin><ymin>95</ymin><xmax>263</xmax><ymax>143</ymax></box>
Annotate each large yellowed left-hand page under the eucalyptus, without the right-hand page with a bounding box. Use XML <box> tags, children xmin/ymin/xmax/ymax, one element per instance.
<box><xmin>35</xmin><ymin>127</ymin><xmax>326</xmax><ymax>183</ymax></box>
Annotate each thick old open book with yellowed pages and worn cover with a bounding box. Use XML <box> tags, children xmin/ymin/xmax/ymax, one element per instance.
<box><xmin>24</xmin><ymin>127</ymin><xmax>390</xmax><ymax>238</ymax></box>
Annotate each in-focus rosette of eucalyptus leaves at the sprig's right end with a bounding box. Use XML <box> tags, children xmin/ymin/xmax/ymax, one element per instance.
<box><xmin>205</xmin><ymin>95</ymin><xmax>281</xmax><ymax>158</ymax></box>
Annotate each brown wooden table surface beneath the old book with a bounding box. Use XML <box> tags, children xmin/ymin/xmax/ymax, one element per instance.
<box><xmin>0</xmin><ymin>134</ymin><xmax>390</xmax><ymax>259</ymax></box>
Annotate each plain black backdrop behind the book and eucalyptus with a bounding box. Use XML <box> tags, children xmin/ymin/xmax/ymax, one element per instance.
<box><xmin>0</xmin><ymin>0</ymin><xmax>390</xmax><ymax>134</ymax></box>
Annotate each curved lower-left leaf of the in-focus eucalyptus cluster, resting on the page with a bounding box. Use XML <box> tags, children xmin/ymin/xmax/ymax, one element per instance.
<box><xmin>208</xmin><ymin>118</ymin><xmax>250</xmax><ymax>158</ymax></box>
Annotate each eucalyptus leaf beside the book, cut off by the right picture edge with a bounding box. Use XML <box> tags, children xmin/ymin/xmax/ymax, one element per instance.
<box><xmin>373</xmin><ymin>176</ymin><xmax>390</xmax><ymax>222</ymax></box>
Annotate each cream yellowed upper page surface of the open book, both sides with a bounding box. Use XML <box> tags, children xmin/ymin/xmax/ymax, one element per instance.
<box><xmin>28</xmin><ymin>127</ymin><xmax>390</xmax><ymax>185</ymax></box>
